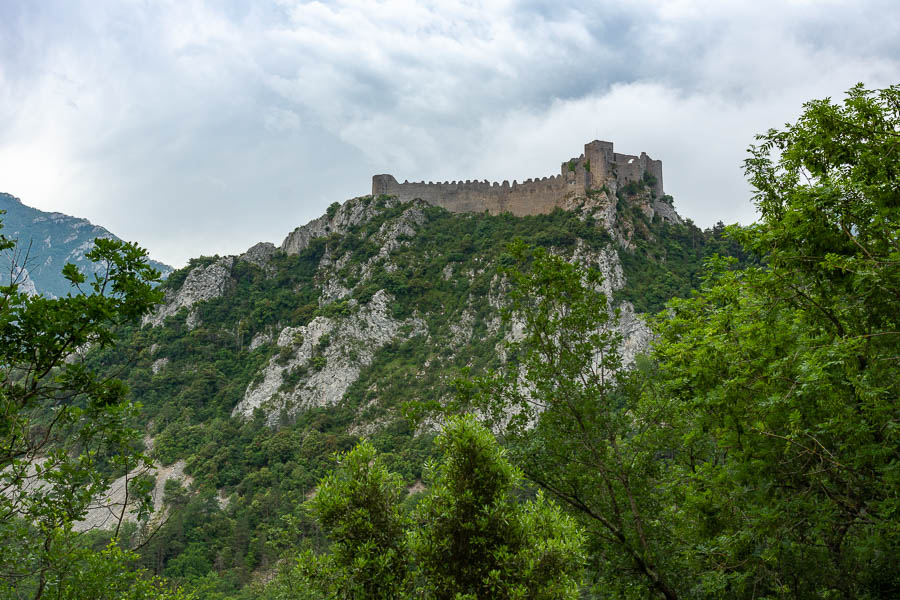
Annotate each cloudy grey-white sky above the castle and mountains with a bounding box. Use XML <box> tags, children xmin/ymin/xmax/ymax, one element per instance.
<box><xmin>0</xmin><ymin>0</ymin><xmax>900</xmax><ymax>266</ymax></box>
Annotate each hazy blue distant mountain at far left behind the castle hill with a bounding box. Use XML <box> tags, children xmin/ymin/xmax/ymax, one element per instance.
<box><xmin>0</xmin><ymin>192</ymin><xmax>173</xmax><ymax>297</ymax></box>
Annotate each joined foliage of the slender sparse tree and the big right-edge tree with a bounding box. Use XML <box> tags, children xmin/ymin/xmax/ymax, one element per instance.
<box><xmin>463</xmin><ymin>87</ymin><xmax>900</xmax><ymax>598</ymax></box>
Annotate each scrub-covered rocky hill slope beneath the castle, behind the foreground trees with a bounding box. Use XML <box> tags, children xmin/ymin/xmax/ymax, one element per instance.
<box><xmin>81</xmin><ymin>184</ymin><xmax>748</xmax><ymax>591</ymax></box>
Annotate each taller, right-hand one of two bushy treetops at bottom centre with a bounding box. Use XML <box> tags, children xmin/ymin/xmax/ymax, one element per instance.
<box><xmin>409</xmin><ymin>417</ymin><xmax>583</xmax><ymax>600</ymax></box>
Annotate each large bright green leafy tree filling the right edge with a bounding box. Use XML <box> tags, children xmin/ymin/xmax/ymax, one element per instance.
<box><xmin>655</xmin><ymin>86</ymin><xmax>900</xmax><ymax>598</ymax></box>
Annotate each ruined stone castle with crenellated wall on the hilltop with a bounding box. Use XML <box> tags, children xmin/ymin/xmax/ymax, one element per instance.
<box><xmin>372</xmin><ymin>140</ymin><xmax>664</xmax><ymax>216</ymax></box>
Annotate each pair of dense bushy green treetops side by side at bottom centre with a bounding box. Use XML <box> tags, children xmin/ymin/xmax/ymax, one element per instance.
<box><xmin>260</xmin><ymin>417</ymin><xmax>583</xmax><ymax>600</ymax></box>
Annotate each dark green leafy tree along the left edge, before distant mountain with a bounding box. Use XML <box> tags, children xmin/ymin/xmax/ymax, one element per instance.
<box><xmin>0</xmin><ymin>217</ymin><xmax>165</xmax><ymax>598</ymax></box>
